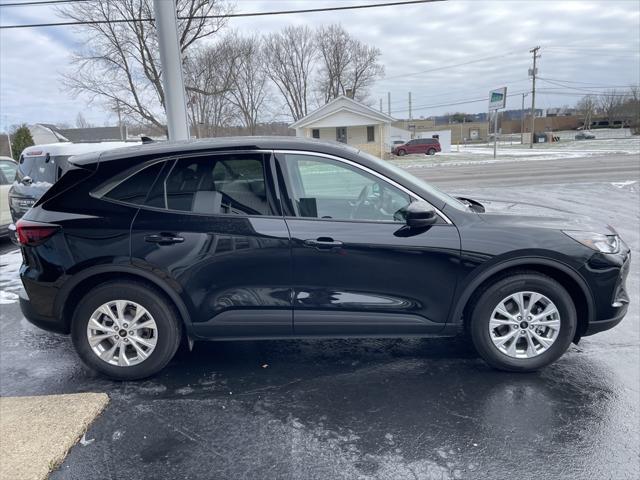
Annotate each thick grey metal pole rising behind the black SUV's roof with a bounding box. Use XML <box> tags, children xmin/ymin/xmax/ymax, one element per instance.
<box><xmin>153</xmin><ymin>0</ymin><xmax>189</xmax><ymax>140</ymax></box>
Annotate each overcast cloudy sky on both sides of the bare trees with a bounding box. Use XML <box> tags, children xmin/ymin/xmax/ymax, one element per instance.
<box><xmin>0</xmin><ymin>0</ymin><xmax>640</xmax><ymax>127</ymax></box>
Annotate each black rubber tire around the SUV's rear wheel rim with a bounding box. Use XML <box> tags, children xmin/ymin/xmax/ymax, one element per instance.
<box><xmin>71</xmin><ymin>281</ymin><xmax>182</xmax><ymax>380</ymax></box>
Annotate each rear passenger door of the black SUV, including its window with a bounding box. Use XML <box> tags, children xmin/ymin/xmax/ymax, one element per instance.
<box><xmin>131</xmin><ymin>153</ymin><xmax>293</xmax><ymax>337</ymax></box>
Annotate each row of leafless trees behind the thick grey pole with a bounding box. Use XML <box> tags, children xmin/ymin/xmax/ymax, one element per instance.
<box><xmin>57</xmin><ymin>0</ymin><xmax>384</xmax><ymax>136</ymax></box>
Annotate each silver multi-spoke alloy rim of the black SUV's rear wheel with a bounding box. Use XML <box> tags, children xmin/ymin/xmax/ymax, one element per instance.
<box><xmin>87</xmin><ymin>300</ymin><xmax>158</xmax><ymax>367</ymax></box>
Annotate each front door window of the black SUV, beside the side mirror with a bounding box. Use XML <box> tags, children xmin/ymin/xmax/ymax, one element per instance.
<box><xmin>285</xmin><ymin>154</ymin><xmax>411</xmax><ymax>222</ymax></box>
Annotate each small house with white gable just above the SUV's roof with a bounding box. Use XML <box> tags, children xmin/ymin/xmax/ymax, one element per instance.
<box><xmin>289</xmin><ymin>95</ymin><xmax>408</xmax><ymax>158</ymax></box>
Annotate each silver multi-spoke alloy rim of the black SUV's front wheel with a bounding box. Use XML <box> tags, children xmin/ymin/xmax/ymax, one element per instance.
<box><xmin>489</xmin><ymin>292</ymin><xmax>561</xmax><ymax>358</ymax></box>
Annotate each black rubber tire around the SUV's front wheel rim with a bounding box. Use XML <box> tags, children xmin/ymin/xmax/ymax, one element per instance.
<box><xmin>469</xmin><ymin>272</ymin><xmax>577</xmax><ymax>372</ymax></box>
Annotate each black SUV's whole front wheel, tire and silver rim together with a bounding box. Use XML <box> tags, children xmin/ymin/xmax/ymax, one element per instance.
<box><xmin>470</xmin><ymin>273</ymin><xmax>577</xmax><ymax>372</ymax></box>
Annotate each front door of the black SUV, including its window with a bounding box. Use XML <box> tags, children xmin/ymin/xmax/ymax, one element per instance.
<box><xmin>277</xmin><ymin>153</ymin><xmax>460</xmax><ymax>335</ymax></box>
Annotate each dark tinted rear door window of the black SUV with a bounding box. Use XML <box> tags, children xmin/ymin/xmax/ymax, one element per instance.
<box><xmin>159</xmin><ymin>154</ymin><xmax>274</xmax><ymax>215</ymax></box>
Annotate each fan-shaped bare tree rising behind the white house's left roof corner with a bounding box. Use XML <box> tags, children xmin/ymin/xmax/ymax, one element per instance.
<box><xmin>263</xmin><ymin>26</ymin><xmax>317</xmax><ymax>120</ymax></box>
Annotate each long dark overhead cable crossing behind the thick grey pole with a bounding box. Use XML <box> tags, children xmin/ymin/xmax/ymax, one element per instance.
<box><xmin>0</xmin><ymin>0</ymin><xmax>446</xmax><ymax>29</ymax></box>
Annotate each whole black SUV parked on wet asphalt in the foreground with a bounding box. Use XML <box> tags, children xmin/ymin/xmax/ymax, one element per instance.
<box><xmin>17</xmin><ymin>137</ymin><xmax>630</xmax><ymax>379</ymax></box>
